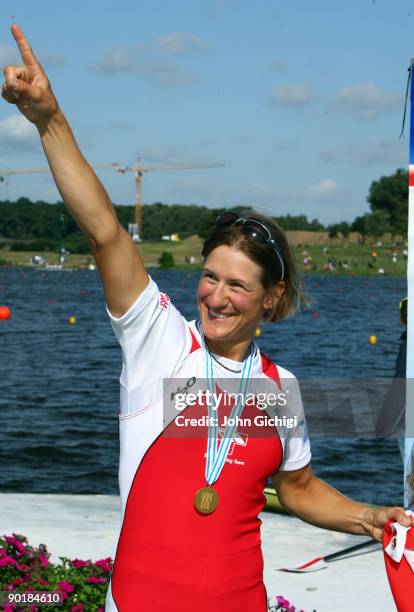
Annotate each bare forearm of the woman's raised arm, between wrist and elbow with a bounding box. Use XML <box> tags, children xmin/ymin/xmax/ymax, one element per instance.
<box><xmin>36</xmin><ymin>109</ymin><xmax>118</xmax><ymax>246</ymax></box>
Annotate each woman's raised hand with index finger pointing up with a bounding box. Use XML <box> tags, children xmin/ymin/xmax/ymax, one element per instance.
<box><xmin>2</xmin><ymin>24</ymin><xmax>59</xmax><ymax>125</ymax></box>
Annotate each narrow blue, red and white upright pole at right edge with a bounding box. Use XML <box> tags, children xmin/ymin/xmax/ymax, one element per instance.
<box><xmin>404</xmin><ymin>59</ymin><xmax>414</xmax><ymax>508</ymax></box>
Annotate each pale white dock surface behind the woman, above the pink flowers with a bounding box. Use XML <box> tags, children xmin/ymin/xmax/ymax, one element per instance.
<box><xmin>0</xmin><ymin>493</ymin><xmax>396</xmax><ymax>612</ymax></box>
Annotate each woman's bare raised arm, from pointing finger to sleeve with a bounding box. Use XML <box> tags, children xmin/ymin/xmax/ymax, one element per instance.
<box><xmin>2</xmin><ymin>24</ymin><xmax>149</xmax><ymax>317</ymax></box>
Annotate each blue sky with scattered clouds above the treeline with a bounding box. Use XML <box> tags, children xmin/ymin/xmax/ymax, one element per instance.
<box><xmin>0</xmin><ymin>0</ymin><xmax>414</xmax><ymax>223</ymax></box>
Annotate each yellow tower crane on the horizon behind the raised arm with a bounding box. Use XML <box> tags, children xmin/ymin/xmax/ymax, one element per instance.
<box><xmin>0</xmin><ymin>159</ymin><xmax>225</xmax><ymax>242</ymax></box>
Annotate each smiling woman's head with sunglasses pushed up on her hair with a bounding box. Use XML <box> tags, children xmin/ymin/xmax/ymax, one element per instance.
<box><xmin>197</xmin><ymin>212</ymin><xmax>301</xmax><ymax>361</ymax></box>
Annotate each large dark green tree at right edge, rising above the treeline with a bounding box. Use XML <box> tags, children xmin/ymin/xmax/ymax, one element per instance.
<box><xmin>367</xmin><ymin>168</ymin><xmax>408</xmax><ymax>235</ymax></box>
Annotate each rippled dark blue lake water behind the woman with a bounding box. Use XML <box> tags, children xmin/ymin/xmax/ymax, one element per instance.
<box><xmin>0</xmin><ymin>267</ymin><xmax>406</xmax><ymax>504</ymax></box>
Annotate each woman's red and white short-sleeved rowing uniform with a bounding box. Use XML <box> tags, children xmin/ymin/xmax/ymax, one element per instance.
<box><xmin>105</xmin><ymin>280</ymin><xmax>311</xmax><ymax>612</ymax></box>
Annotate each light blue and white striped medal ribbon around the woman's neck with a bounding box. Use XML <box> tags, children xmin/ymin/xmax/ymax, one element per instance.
<box><xmin>205</xmin><ymin>348</ymin><xmax>254</xmax><ymax>485</ymax></box>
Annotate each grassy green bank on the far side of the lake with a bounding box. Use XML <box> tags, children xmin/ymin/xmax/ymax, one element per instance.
<box><xmin>0</xmin><ymin>236</ymin><xmax>407</xmax><ymax>276</ymax></box>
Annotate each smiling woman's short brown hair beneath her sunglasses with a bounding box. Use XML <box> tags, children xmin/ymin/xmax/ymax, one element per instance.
<box><xmin>202</xmin><ymin>210</ymin><xmax>302</xmax><ymax>322</ymax></box>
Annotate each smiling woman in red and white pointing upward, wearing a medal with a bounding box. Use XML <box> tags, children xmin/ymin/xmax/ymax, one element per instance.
<box><xmin>2</xmin><ymin>25</ymin><xmax>411</xmax><ymax>612</ymax></box>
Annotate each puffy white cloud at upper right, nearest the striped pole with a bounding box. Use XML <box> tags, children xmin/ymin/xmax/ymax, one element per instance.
<box><xmin>332</xmin><ymin>82</ymin><xmax>400</xmax><ymax>120</ymax></box>
